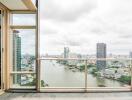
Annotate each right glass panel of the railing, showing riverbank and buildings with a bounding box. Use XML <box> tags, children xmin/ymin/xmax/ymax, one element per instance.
<box><xmin>87</xmin><ymin>59</ymin><xmax>131</xmax><ymax>87</ymax></box>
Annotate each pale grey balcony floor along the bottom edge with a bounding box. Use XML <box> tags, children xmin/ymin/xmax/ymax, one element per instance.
<box><xmin>0</xmin><ymin>92</ymin><xmax>132</xmax><ymax>100</ymax></box>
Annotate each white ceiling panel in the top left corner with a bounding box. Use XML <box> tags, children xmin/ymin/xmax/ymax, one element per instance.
<box><xmin>0</xmin><ymin>0</ymin><xmax>28</xmax><ymax>10</ymax></box>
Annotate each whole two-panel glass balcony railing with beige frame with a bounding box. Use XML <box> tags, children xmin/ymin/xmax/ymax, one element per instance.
<box><xmin>40</xmin><ymin>58</ymin><xmax>132</xmax><ymax>88</ymax></box>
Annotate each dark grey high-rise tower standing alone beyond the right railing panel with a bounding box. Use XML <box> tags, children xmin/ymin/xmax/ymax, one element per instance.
<box><xmin>96</xmin><ymin>43</ymin><xmax>106</xmax><ymax>70</ymax></box>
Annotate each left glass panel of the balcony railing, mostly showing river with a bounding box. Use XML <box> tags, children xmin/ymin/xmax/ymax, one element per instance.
<box><xmin>41</xmin><ymin>60</ymin><xmax>85</xmax><ymax>87</ymax></box>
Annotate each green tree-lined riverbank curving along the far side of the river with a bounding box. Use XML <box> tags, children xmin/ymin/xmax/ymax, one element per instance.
<box><xmin>57</xmin><ymin>61</ymin><xmax>131</xmax><ymax>87</ymax></box>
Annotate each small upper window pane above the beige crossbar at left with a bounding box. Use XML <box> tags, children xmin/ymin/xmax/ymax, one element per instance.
<box><xmin>11</xmin><ymin>14</ymin><xmax>36</xmax><ymax>25</ymax></box>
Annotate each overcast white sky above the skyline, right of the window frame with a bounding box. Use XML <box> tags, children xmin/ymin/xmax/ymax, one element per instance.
<box><xmin>40</xmin><ymin>0</ymin><xmax>132</xmax><ymax>54</ymax></box>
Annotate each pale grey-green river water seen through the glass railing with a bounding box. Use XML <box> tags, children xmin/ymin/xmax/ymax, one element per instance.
<box><xmin>41</xmin><ymin>60</ymin><xmax>126</xmax><ymax>87</ymax></box>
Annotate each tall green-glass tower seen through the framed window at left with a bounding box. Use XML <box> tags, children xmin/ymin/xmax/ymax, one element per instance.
<box><xmin>13</xmin><ymin>30</ymin><xmax>21</xmax><ymax>84</ymax></box>
